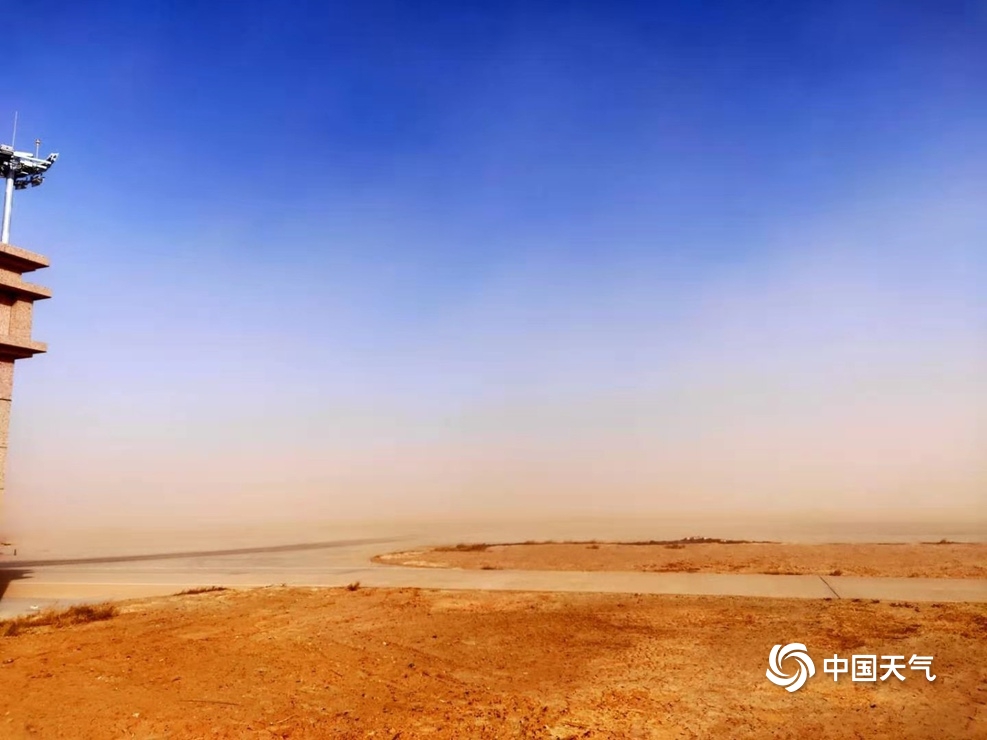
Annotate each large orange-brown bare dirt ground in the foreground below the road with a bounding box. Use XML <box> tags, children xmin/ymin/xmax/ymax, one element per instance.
<box><xmin>0</xmin><ymin>588</ymin><xmax>987</xmax><ymax>740</ymax></box>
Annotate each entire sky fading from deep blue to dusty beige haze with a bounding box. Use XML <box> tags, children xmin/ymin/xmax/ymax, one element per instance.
<box><xmin>0</xmin><ymin>0</ymin><xmax>987</xmax><ymax>526</ymax></box>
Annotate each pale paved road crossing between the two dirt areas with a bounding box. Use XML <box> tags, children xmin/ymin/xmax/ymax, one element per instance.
<box><xmin>0</xmin><ymin>536</ymin><xmax>987</xmax><ymax>616</ymax></box>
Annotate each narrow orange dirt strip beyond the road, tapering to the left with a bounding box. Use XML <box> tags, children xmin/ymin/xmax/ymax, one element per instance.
<box><xmin>375</xmin><ymin>539</ymin><xmax>987</xmax><ymax>578</ymax></box>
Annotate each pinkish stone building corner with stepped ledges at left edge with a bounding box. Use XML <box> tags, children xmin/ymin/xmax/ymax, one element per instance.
<box><xmin>0</xmin><ymin>243</ymin><xmax>51</xmax><ymax>520</ymax></box>
